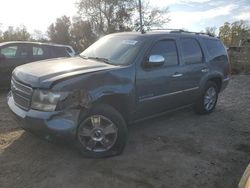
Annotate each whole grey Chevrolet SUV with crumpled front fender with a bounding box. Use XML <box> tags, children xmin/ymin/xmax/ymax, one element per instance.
<box><xmin>8</xmin><ymin>30</ymin><xmax>230</xmax><ymax>157</ymax></box>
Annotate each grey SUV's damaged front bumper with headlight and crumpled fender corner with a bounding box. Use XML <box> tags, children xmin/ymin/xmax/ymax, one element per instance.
<box><xmin>8</xmin><ymin>90</ymin><xmax>94</xmax><ymax>140</ymax></box>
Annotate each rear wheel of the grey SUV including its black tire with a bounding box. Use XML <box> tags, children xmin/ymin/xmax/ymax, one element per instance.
<box><xmin>194</xmin><ymin>81</ymin><xmax>219</xmax><ymax>114</ymax></box>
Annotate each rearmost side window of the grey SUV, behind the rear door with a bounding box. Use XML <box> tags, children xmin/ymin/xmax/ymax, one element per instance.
<box><xmin>203</xmin><ymin>39</ymin><xmax>226</xmax><ymax>58</ymax></box>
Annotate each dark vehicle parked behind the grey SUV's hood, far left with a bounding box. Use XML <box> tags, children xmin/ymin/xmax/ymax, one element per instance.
<box><xmin>0</xmin><ymin>41</ymin><xmax>75</xmax><ymax>88</ymax></box>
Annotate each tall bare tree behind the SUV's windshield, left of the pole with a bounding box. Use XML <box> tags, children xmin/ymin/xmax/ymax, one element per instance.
<box><xmin>77</xmin><ymin>0</ymin><xmax>134</xmax><ymax>35</ymax></box>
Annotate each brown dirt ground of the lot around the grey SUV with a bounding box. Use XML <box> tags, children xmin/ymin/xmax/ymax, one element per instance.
<box><xmin>0</xmin><ymin>76</ymin><xmax>250</xmax><ymax>188</ymax></box>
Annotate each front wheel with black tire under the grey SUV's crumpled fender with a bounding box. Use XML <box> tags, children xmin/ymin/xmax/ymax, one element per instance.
<box><xmin>77</xmin><ymin>104</ymin><xmax>127</xmax><ymax>158</ymax></box>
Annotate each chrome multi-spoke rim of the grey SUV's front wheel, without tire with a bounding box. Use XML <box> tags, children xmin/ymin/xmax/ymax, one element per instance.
<box><xmin>78</xmin><ymin>115</ymin><xmax>118</xmax><ymax>152</ymax></box>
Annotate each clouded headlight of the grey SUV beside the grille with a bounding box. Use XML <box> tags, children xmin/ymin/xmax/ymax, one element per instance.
<box><xmin>31</xmin><ymin>89</ymin><xmax>64</xmax><ymax>111</ymax></box>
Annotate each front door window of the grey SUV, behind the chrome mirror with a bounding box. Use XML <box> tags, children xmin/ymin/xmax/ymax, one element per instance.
<box><xmin>150</xmin><ymin>40</ymin><xmax>178</xmax><ymax>66</ymax></box>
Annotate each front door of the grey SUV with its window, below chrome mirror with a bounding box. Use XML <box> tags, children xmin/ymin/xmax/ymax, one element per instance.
<box><xmin>136</xmin><ymin>39</ymin><xmax>188</xmax><ymax>118</ymax></box>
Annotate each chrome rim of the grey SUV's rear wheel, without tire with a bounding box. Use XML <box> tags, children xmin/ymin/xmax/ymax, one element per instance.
<box><xmin>203</xmin><ymin>87</ymin><xmax>217</xmax><ymax>111</ymax></box>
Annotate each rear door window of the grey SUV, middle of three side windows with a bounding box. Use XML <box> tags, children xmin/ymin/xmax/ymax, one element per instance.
<box><xmin>181</xmin><ymin>38</ymin><xmax>203</xmax><ymax>65</ymax></box>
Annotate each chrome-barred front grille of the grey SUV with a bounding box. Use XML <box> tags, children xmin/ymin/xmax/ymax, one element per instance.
<box><xmin>11</xmin><ymin>78</ymin><xmax>33</xmax><ymax>110</ymax></box>
